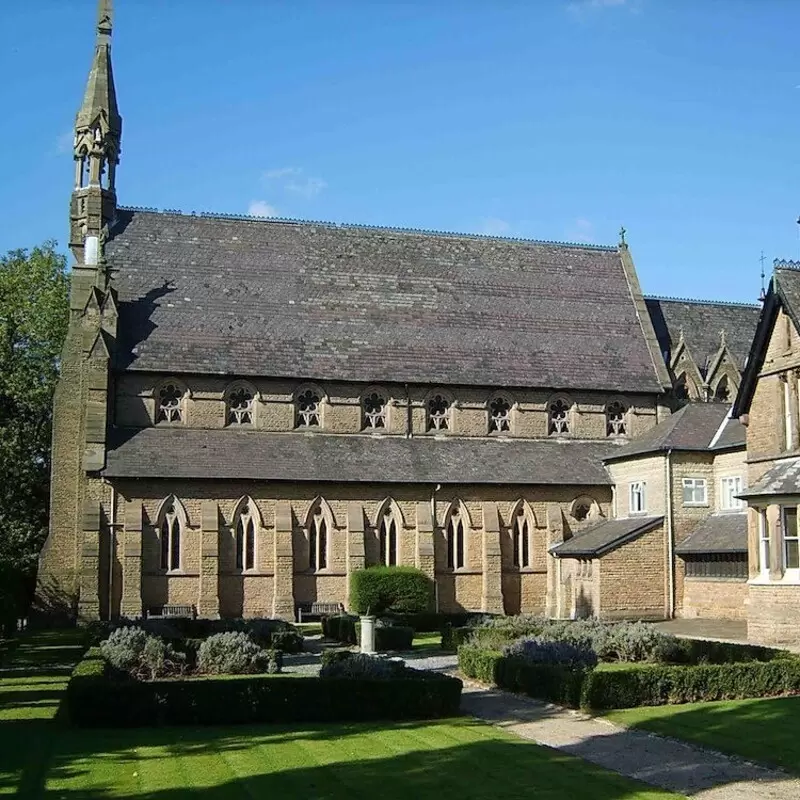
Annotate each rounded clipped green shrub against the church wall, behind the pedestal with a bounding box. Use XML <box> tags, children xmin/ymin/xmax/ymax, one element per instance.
<box><xmin>350</xmin><ymin>567</ymin><xmax>433</xmax><ymax>614</ymax></box>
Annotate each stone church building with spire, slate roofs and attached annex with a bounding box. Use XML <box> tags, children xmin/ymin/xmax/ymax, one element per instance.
<box><xmin>39</xmin><ymin>0</ymin><xmax>764</xmax><ymax>619</ymax></box>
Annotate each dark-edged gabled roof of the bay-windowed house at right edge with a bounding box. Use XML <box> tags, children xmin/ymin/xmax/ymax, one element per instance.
<box><xmin>733</xmin><ymin>268</ymin><xmax>800</xmax><ymax>417</ymax></box>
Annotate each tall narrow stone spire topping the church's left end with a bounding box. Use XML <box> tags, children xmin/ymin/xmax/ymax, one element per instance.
<box><xmin>70</xmin><ymin>0</ymin><xmax>122</xmax><ymax>265</ymax></box>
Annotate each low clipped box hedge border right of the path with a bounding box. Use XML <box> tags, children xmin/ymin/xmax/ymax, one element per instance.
<box><xmin>458</xmin><ymin>644</ymin><xmax>800</xmax><ymax>710</ymax></box>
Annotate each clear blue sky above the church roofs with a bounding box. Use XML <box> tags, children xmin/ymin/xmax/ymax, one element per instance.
<box><xmin>0</xmin><ymin>0</ymin><xmax>800</xmax><ymax>301</ymax></box>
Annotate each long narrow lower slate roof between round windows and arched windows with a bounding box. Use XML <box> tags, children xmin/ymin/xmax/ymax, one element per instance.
<box><xmin>104</xmin><ymin>427</ymin><xmax>615</xmax><ymax>486</ymax></box>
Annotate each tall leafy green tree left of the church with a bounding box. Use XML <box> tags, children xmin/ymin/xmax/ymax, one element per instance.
<box><xmin>0</xmin><ymin>242</ymin><xmax>69</xmax><ymax>621</ymax></box>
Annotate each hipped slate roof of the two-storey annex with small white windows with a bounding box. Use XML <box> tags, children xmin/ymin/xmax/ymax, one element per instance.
<box><xmin>606</xmin><ymin>403</ymin><xmax>744</xmax><ymax>461</ymax></box>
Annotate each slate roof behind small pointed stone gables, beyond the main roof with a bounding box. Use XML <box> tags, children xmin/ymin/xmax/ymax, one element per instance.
<box><xmin>645</xmin><ymin>297</ymin><xmax>761</xmax><ymax>374</ymax></box>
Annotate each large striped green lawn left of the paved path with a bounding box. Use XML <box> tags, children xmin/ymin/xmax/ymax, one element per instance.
<box><xmin>0</xmin><ymin>634</ymin><xmax>676</xmax><ymax>800</ymax></box>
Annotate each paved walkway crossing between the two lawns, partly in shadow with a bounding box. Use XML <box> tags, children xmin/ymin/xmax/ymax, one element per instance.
<box><xmin>461</xmin><ymin>683</ymin><xmax>800</xmax><ymax>800</ymax></box>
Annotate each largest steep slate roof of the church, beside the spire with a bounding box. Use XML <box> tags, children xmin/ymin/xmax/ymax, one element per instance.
<box><xmin>106</xmin><ymin>209</ymin><xmax>661</xmax><ymax>392</ymax></box>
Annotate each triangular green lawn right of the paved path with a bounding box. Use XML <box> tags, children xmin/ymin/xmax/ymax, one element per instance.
<box><xmin>604</xmin><ymin>697</ymin><xmax>800</xmax><ymax>774</ymax></box>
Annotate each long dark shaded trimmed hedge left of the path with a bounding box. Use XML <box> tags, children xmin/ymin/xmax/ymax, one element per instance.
<box><xmin>66</xmin><ymin>648</ymin><xmax>462</xmax><ymax>727</ymax></box>
